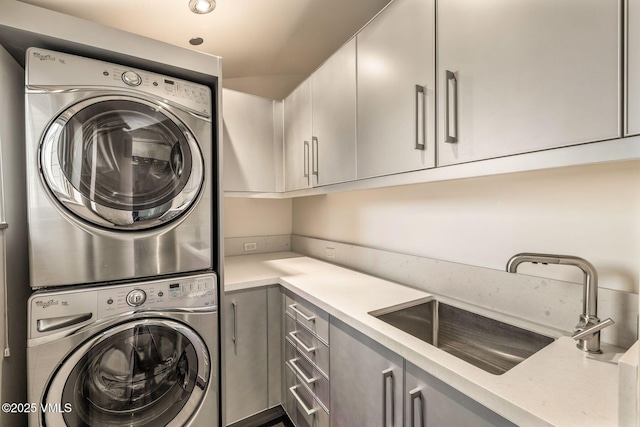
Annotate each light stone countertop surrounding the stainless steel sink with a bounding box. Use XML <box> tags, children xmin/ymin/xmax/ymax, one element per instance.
<box><xmin>224</xmin><ymin>252</ymin><xmax>624</xmax><ymax>427</ymax></box>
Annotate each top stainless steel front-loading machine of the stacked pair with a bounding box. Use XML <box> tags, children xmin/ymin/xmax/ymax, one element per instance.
<box><xmin>26</xmin><ymin>48</ymin><xmax>217</xmax><ymax>288</ymax></box>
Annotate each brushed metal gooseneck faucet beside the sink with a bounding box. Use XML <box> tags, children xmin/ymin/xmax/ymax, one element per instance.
<box><xmin>507</xmin><ymin>253</ymin><xmax>614</xmax><ymax>353</ymax></box>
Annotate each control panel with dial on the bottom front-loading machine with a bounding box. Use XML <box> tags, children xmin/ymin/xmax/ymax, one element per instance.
<box><xmin>29</xmin><ymin>273</ymin><xmax>217</xmax><ymax>339</ymax></box>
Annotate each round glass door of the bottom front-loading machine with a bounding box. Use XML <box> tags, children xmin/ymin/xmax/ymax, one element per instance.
<box><xmin>43</xmin><ymin>319</ymin><xmax>211</xmax><ymax>427</ymax></box>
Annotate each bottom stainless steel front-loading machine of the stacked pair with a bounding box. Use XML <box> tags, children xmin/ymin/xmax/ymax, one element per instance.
<box><xmin>27</xmin><ymin>274</ymin><xmax>219</xmax><ymax>427</ymax></box>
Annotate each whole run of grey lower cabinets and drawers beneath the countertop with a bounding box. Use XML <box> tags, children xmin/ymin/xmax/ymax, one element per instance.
<box><xmin>230</xmin><ymin>286</ymin><xmax>515</xmax><ymax>427</ymax></box>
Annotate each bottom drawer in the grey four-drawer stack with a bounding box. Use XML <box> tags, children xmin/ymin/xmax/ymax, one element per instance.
<box><xmin>285</xmin><ymin>368</ymin><xmax>329</xmax><ymax>427</ymax></box>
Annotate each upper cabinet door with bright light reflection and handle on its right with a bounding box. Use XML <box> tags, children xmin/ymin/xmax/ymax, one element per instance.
<box><xmin>357</xmin><ymin>0</ymin><xmax>435</xmax><ymax>178</ymax></box>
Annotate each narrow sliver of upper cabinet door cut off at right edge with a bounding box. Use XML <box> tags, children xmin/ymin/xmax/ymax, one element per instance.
<box><xmin>625</xmin><ymin>0</ymin><xmax>640</xmax><ymax>135</ymax></box>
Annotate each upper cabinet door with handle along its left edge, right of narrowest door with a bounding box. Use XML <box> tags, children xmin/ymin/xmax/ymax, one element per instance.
<box><xmin>311</xmin><ymin>38</ymin><xmax>356</xmax><ymax>186</ymax></box>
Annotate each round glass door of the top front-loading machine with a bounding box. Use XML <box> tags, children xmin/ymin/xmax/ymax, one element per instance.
<box><xmin>40</xmin><ymin>96</ymin><xmax>204</xmax><ymax>230</ymax></box>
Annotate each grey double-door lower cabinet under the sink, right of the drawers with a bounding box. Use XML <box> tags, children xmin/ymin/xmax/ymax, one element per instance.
<box><xmin>329</xmin><ymin>319</ymin><xmax>515</xmax><ymax>427</ymax></box>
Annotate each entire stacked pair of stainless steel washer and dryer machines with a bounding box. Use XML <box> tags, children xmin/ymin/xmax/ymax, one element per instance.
<box><xmin>25</xmin><ymin>48</ymin><xmax>219</xmax><ymax>427</ymax></box>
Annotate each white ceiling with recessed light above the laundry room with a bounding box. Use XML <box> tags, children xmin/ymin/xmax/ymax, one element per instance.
<box><xmin>22</xmin><ymin>0</ymin><xmax>389</xmax><ymax>99</ymax></box>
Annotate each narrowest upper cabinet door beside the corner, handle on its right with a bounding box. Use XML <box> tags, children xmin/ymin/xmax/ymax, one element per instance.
<box><xmin>284</xmin><ymin>79</ymin><xmax>311</xmax><ymax>191</ymax></box>
